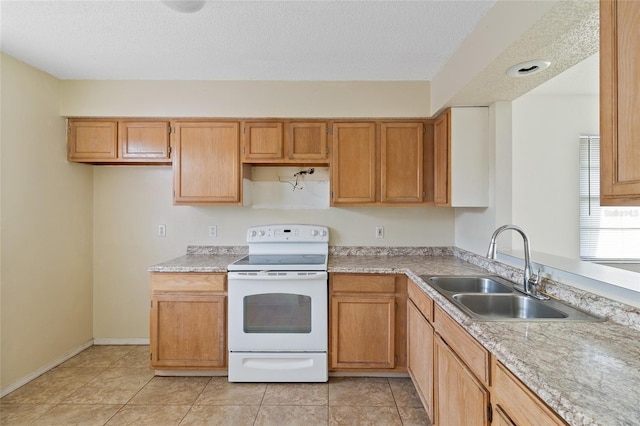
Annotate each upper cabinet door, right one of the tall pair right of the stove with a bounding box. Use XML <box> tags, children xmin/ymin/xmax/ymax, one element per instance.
<box><xmin>380</xmin><ymin>123</ymin><xmax>424</xmax><ymax>203</ymax></box>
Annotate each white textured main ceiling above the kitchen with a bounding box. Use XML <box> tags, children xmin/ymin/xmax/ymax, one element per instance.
<box><xmin>0</xmin><ymin>0</ymin><xmax>494</xmax><ymax>81</ymax></box>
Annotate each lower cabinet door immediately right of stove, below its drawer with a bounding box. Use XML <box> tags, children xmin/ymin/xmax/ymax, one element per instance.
<box><xmin>330</xmin><ymin>294</ymin><xmax>396</xmax><ymax>369</ymax></box>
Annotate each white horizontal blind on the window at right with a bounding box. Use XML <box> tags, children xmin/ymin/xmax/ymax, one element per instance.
<box><xmin>580</xmin><ymin>136</ymin><xmax>640</xmax><ymax>263</ymax></box>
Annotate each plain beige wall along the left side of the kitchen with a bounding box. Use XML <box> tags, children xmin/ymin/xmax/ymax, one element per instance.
<box><xmin>0</xmin><ymin>54</ymin><xmax>93</xmax><ymax>389</ymax></box>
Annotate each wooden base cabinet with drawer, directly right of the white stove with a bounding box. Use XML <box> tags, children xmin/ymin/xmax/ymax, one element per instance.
<box><xmin>329</xmin><ymin>274</ymin><xmax>406</xmax><ymax>372</ymax></box>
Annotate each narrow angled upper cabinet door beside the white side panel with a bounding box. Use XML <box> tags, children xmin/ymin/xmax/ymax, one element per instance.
<box><xmin>433</xmin><ymin>110</ymin><xmax>451</xmax><ymax>206</ymax></box>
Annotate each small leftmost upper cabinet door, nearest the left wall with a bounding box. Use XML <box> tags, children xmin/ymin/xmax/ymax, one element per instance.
<box><xmin>67</xmin><ymin>119</ymin><xmax>118</xmax><ymax>163</ymax></box>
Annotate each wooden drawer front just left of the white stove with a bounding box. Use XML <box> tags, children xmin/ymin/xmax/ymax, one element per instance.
<box><xmin>151</xmin><ymin>272</ymin><xmax>227</xmax><ymax>292</ymax></box>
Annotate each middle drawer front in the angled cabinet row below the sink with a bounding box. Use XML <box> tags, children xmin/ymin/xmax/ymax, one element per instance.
<box><xmin>434</xmin><ymin>306</ymin><xmax>489</xmax><ymax>386</ymax></box>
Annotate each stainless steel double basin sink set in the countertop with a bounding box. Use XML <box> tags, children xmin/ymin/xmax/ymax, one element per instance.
<box><xmin>421</xmin><ymin>275</ymin><xmax>602</xmax><ymax>321</ymax></box>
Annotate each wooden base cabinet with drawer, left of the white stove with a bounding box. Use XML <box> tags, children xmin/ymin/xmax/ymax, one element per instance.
<box><xmin>149</xmin><ymin>273</ymin><xmax>227</xmax><ymax>370</ymax></box>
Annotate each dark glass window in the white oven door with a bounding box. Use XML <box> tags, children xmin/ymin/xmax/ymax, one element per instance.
<box><xmin>243</xmin><ymin>293</ymin><xmax>311</xmax><ymax>333</ymax></box>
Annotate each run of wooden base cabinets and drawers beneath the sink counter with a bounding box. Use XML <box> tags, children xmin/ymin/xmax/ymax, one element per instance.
<box><xmin>407</xmin><ymin>280</ymin><xmax>567</xmax><ymax>426</ymax></box>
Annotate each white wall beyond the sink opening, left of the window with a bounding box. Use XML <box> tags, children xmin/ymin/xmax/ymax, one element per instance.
<box><xmin>513</xmin><ymin>94</ymin><xmax>600</xmax><ymax>259</ymax></box>
